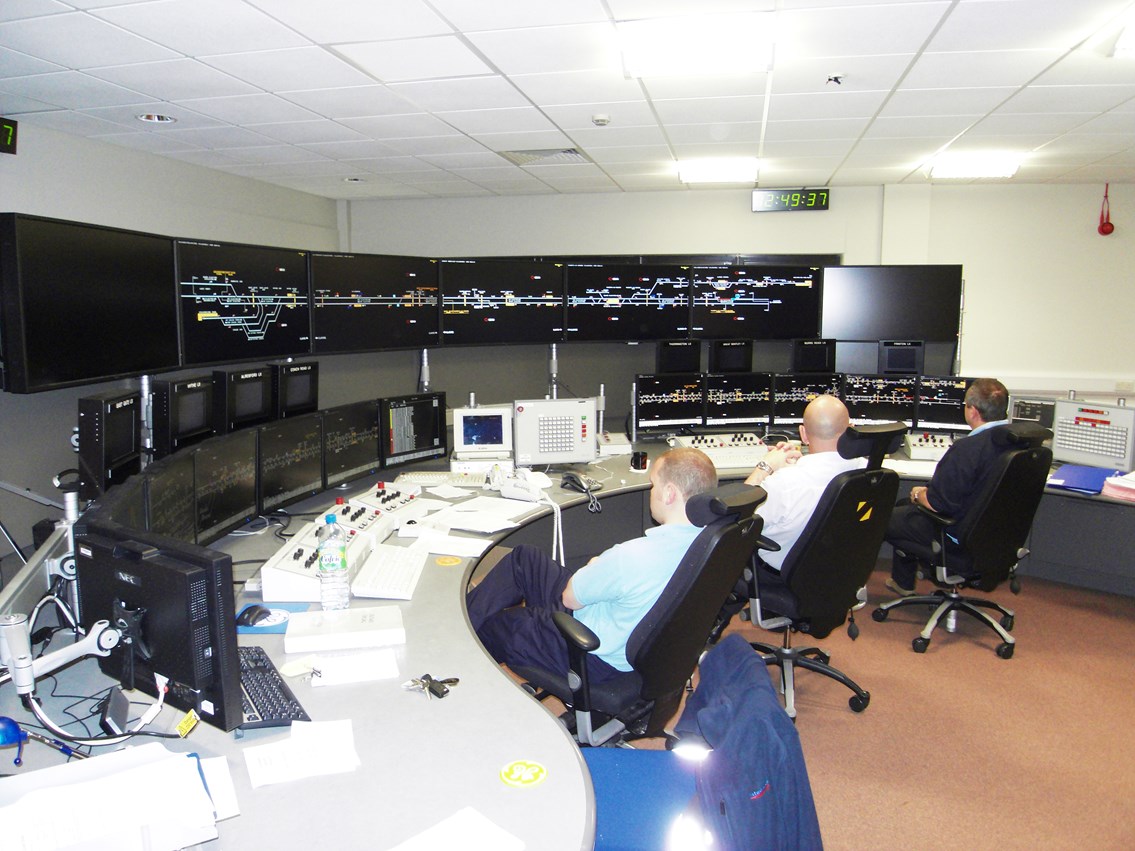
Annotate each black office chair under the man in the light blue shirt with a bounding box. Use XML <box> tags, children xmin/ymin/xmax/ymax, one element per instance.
<box><xmin>513</xmin><ymin>485</ymin><xmax>766</xmax><ymax>745</ymax></box>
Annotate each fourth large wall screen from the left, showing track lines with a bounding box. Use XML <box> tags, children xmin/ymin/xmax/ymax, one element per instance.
<box><xmin>440</xmin><ymin>260</ymin><xmax>564</xmax><ymax>344</ymax></box>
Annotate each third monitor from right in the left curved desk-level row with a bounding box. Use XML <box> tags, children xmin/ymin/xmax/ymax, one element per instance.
<box><xmin>257</xmin><ymin>414</ymin><xmax>323</xmax><ymax>512</ymax></box>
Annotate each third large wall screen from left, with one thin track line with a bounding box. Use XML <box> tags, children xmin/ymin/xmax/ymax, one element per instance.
<box><xmin>311</xmin><ymin>253</ymin><xmax>438</xmax><ymax>354</ymax></box>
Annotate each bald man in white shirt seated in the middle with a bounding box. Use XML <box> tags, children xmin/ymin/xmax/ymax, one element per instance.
<box><xmin>745</xmin><ymin>395</ymin><xmax>867</xmax><ymax>571</ymax></box>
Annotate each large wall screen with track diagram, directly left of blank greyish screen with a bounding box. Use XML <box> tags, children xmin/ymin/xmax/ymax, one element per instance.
<box><xmin>690</xmin><ymin>266</ymin><xmax>823</xmax><ymax>339</ymax></box>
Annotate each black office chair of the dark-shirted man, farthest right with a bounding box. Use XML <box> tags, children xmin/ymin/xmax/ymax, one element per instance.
<box><xmin>872</xmin><ymin>423</ymin><xmax>1052</xmax><ymax>659</ymax></box>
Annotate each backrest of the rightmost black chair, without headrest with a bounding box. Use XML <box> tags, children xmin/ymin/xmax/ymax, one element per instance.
<box><xmin>945</xmin><ymin>435</ymin><xmax>1052</xmax><ymax>591</ymax></box>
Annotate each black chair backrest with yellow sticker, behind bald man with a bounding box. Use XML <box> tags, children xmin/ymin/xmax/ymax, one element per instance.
<box><xmin>781</xmin><ymin>469</ymin><xmax>899</xmax><ymax>638</ymax></box>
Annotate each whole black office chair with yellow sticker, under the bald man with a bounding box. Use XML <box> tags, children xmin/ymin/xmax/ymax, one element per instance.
<box><xmin>741</xmin><ymin>423</ymin><xmax>907</xmax><ymax>718</ymax></box>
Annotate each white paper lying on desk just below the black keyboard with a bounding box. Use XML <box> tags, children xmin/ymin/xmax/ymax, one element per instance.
<box><xmin>244</xmin><ymin>719</ymin><xmax>361</xmax><ymax>789</ymax></box>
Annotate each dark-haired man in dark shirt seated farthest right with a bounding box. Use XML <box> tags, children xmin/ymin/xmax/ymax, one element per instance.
<box><xmin>886</xmin><ymin>378</ymin><xmax>1009</xmax><ymax>597</ymax></box>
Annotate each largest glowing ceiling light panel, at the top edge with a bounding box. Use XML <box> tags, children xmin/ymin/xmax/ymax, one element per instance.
<box><xmin>615</xmin><ymin>12</ymin><xmax>774</xmax><ymax>77</ymax></box>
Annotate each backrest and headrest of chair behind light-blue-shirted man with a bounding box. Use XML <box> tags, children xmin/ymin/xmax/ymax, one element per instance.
<box><xmin>627</xmin><ymin>486</ymin><xmax>766</xmax><ymax>708</ymax></box>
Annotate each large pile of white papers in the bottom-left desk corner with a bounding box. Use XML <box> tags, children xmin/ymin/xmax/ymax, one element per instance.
<box><xmin>0</xmin><ymin>743</ymin><xmax>217</xmax><ymax>851</ymax></box>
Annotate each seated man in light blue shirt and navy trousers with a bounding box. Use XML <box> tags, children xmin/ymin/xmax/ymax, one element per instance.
<box><xmin>465</xmin><ymin>448</ymin><xmax>717</xmax><ymax>683</ymax></box>
